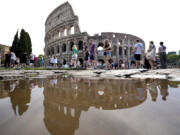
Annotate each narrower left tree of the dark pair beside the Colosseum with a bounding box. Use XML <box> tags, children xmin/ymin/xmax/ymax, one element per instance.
<box><xmin>10</xmin><ymin>31</ymin><xmax>19</xmax><ymax>56</ymax></box>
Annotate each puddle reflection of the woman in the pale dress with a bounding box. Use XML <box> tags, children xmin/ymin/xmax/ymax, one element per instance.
<box><xmin>146</xmin><ymin>79</ymin><xmax>158</xmax><ymax>102</ymax></box>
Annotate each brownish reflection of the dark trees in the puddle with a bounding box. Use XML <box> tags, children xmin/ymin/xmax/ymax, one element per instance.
<box><xmin>9</xmin><ymin>80</ymin><xmax>31</xmax><ymax>115</ymax></box>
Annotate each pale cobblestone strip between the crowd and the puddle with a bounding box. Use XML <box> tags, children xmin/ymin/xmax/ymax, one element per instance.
<box><xmin>0</xmin><ymin>69</ymin><xmax>180</xmax><ymax>81</ymax></box>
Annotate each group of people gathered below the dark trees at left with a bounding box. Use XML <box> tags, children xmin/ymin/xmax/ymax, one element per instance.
<box><xmin>1</xmin><ymin>52</ymin><xmax>44</xmax><ymax>68</ymax></box>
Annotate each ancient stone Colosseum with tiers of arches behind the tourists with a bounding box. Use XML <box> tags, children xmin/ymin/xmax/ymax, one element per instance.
<box><xmin>44</xmin><ymin>2</ymin><xmax>145</xmax><ymax>64</ymax></box>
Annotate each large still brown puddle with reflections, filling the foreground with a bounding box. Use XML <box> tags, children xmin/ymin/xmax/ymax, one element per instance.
<box><xmin>0</xmin><ymin>75</ymin><xmax>180</xmax><ymax>135</ymax></box>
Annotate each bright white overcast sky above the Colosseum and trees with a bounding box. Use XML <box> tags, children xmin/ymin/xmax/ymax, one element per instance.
<box><xmin>0</xmin><ymin>0</ymin><xmax>180</xmax><ymax>55</ymax></box>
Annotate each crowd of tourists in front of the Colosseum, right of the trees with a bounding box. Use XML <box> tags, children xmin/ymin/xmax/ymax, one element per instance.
<box><xmin>49</xmin><ymin>39</ymin><xmax>166</xmax><ymax>70</ymax></box>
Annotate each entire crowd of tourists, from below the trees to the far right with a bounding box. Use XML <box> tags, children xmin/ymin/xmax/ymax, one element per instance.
<box><xmin>0</xmin><ymin>39</ymin><xmax>167</xmax><ymax>70</ymax></box>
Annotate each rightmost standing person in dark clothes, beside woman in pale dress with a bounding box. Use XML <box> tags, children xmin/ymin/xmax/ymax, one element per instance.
<box><xmin>158</xmin><ymin>42</ymin><xmax>166</xmax><ymax>69</ymax></box>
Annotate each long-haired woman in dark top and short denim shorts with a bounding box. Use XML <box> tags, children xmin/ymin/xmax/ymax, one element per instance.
<box><xmin>103</xmin><ymin>39</ymin><xmax>111</xmax><ymax>69</ymax></box>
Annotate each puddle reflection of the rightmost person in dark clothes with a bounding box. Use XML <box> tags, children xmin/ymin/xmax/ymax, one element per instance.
<box><xmin>159</xmin><ymin>80</ymin><xmax>169</xmax><ymax>101</ymax></box>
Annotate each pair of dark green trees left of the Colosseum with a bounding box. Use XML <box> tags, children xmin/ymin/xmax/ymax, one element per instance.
<box><xmin>10</xmin><ymin>29</ymin><xmax>32</xmax><ymax>57</ymax></box>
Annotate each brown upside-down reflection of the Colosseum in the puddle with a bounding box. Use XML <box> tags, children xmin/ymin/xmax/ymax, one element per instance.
<box><xmin>44</xmin><ymin>78</ymin><xmax>147</xmax><ymax>135</ymax></box>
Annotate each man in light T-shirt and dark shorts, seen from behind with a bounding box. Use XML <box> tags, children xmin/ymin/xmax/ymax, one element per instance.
<box><xmin>134</xmin><ymin>40</ymin><xmax>143</xmax><ymax>68</ymax></box>
